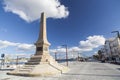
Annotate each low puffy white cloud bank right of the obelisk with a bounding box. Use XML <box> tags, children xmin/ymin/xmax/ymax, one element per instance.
<box><xmin>50</xmin><ymin>35</ymin><xmax>105</xmax><ymax>53</ymax></box>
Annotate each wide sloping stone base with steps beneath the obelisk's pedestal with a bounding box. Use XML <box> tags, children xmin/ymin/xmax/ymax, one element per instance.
<box><xmin>7</xmin><ymin>56</ymin><xmax>69</xmax><ymax>76</ymax></box>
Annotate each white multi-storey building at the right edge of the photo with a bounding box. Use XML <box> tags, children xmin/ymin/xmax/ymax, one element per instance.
<box><xmin>104</xmin><ymin>37</ymin><xmax>120</xmax><ymax>61</ymax></box>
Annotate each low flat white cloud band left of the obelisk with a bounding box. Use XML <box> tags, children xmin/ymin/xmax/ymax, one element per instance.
<box><xmin>0</xmin><ymin>40</ymin><xmax>35</xmax><ymax>51</ymax></box>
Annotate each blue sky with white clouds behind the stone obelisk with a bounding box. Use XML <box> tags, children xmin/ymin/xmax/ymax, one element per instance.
<box><xmin>0</xmin><ymin>0</ymin><xmax>120</xmax><ymax>58</ymax></box>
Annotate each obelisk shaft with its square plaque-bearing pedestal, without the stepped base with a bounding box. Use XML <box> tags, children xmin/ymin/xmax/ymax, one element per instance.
<box><xmin>35</xmin><ymin>13</ymin><xmax>50</xmax><ymax>55</ymax></box>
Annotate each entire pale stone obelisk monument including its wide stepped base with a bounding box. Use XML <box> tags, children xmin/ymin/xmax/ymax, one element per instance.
<box><xmin>7</xmin><ymin>13</ymin><xmax>69</xmax><ymax>76</ymax></box>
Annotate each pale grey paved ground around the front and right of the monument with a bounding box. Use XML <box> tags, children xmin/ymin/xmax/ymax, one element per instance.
<box><xmin>0</xmin><ymin>62</ymin><xmax>120</xmax><ymax>80</ymax></box>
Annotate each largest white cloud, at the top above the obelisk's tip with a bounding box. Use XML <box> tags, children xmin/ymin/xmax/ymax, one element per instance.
<box><xmin>3</xmin><ymin>0</ymin><xmax>69</xmax><ymax>22</ymax></box>
